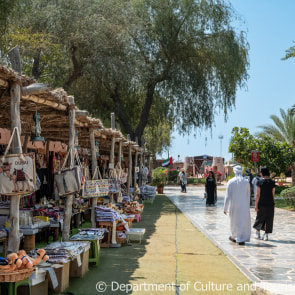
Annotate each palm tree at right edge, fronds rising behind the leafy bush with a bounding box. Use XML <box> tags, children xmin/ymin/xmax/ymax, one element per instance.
<box><xmin>258</xmin><ymin>105</ymin><xmax>295</xmax><ymax>186</ymax></box>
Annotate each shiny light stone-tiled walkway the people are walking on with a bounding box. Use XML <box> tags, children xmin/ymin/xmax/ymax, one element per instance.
<box><xmin>164</xmin><ymin>186</ymin><xmax>295</xmax><ymax>294</ymax></box>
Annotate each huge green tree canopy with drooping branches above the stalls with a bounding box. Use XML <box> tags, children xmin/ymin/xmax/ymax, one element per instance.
<box><xmin>0</xmin><ymin>0</ymin><xmax>248</xmax><ymax>155</ymax></box>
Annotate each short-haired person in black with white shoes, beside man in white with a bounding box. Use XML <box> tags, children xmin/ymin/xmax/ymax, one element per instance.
<box><xmin>253</xmin><ymin>167</ymin><xmax>275</xmax><ymax>241</ymax></box>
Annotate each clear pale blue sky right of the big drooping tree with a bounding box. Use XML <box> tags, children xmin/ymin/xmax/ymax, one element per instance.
<box><xmin>165</xmin><ymin>0</ymin><xmax>295</xmax><ymax>161</ymax></box>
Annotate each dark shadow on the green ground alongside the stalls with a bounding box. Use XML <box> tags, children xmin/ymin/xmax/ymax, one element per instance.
<box><xmin>52</xmin><ymin>195</ymin><xmax>175</xmax><ymax>295</ymax></box>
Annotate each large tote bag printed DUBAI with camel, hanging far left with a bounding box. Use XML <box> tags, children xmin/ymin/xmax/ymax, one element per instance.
<box><xmin>0</xmin><ymin>127</ymin><xmax>36</xmax><ymax>195</ymax></box>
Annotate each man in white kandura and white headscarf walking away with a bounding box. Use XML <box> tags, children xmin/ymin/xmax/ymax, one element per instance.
<box><xmin>223</xmin><ymin>166</ymin><xmax>251</xmax><ymax>245</ymax></box>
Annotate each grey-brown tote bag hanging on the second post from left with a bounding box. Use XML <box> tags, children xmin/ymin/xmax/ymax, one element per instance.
<box><xmin>54</xmin><ymin>148</ymin><xmax>81</xmax><ymax>197</ymax></box>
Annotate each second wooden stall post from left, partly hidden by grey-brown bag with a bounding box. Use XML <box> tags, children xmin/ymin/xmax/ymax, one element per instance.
<box><xmin>62</xmin><ymin>96</ymin><xmax>75</xmax><ymax>241</ymax></box>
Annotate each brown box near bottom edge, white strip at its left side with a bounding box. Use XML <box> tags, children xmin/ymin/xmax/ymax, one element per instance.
<box><xmin>47</xmin><ymin>262</ymin><xmax>70</xmax><ymax>292</ymax></box>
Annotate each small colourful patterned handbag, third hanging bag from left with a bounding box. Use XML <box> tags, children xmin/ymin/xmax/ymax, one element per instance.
<box><xmin>83</xmin><ymin>167</ymin><xmax>109</xmax><ymax>198</ymax></box>
